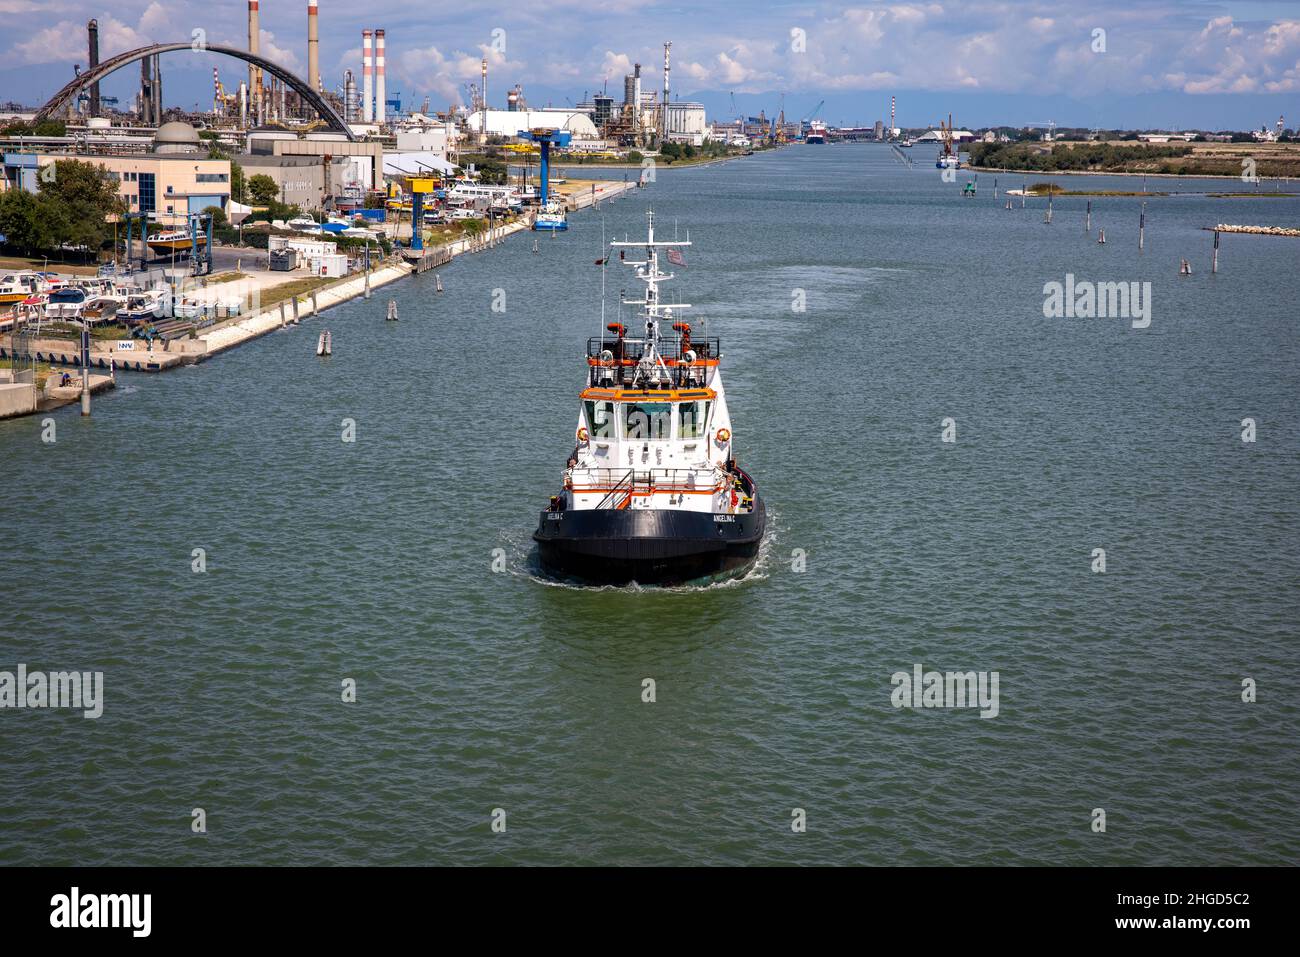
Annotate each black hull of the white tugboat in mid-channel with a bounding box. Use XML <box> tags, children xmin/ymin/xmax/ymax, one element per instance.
<box><xmin>533</xmin><ymin>497</ymin><xmax>767</xmax><ymax>585</ymax></box>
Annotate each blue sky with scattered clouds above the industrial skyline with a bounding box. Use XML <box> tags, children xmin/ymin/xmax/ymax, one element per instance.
<box><xmin>0</xmin><ymin>0</ymin><xmax>1300</xmax><ymax>130</ymax></box>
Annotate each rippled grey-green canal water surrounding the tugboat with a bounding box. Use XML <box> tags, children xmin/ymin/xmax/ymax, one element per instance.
<box><xmin>0</xmin><ymin>146</ymin><xmax>1300</xmax><ymax>865</ymax></box>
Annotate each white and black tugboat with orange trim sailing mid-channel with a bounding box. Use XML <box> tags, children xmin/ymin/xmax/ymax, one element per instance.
<box><xmin>533</xmin><ymin>212</ymin><xmax>767</xmax><ymax>585</ymax></box>
